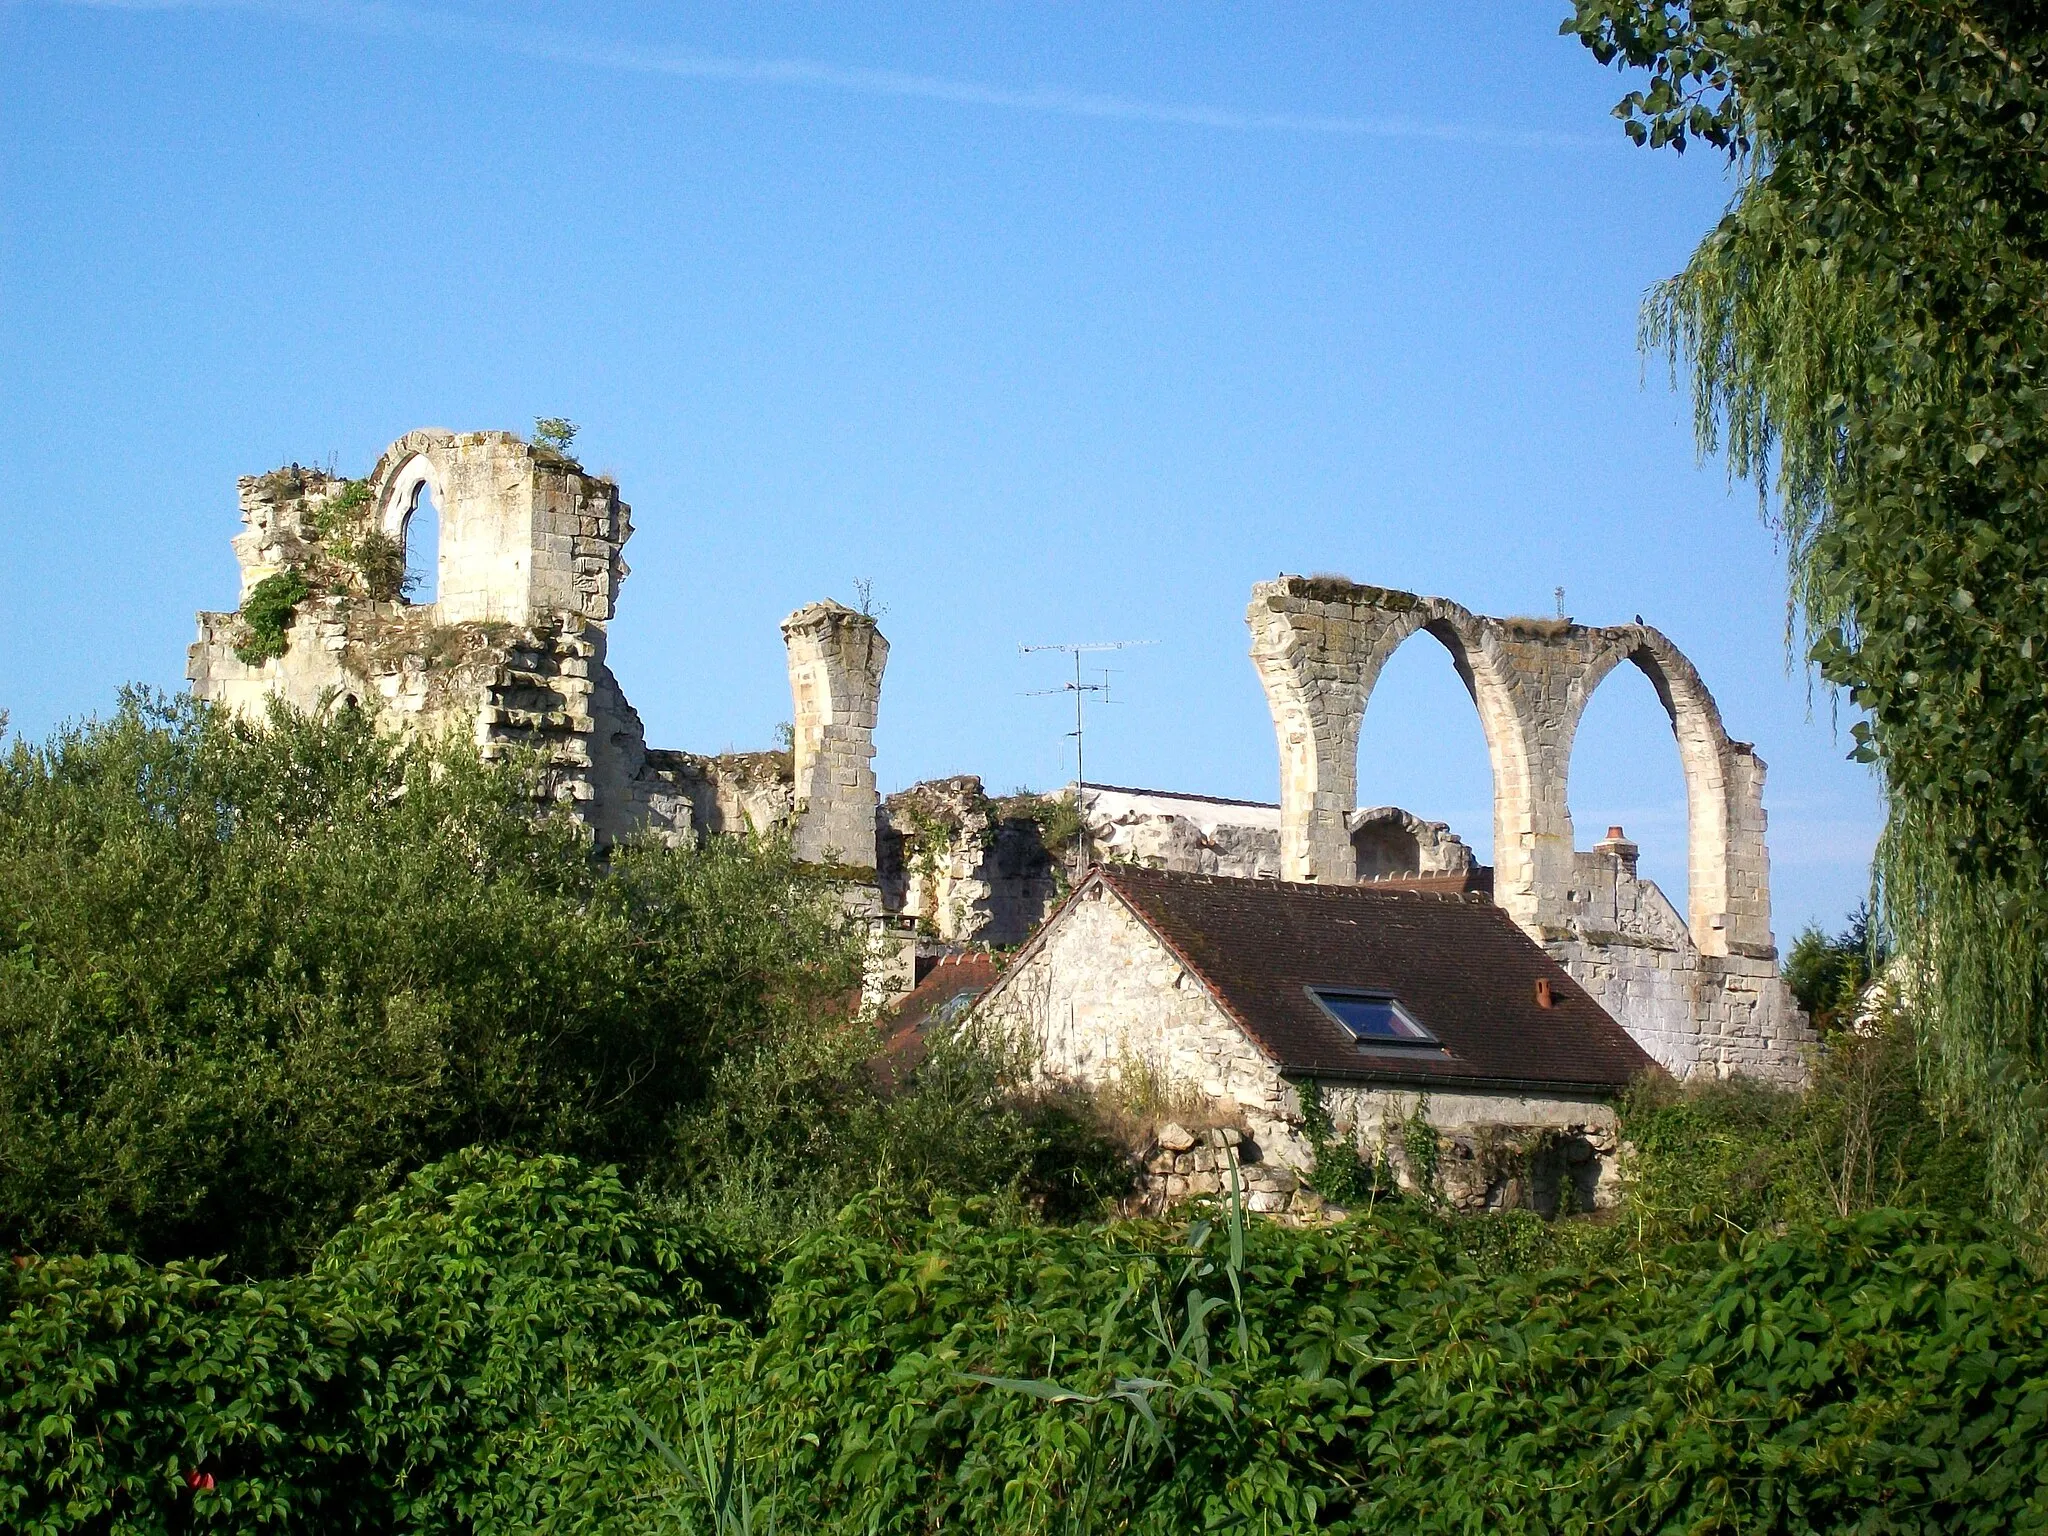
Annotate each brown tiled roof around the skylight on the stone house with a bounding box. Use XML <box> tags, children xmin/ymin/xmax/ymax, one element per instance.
<box><xmin>1077</xmin><ymin>864</ymin><xmax>1657</xmax><ymax>1092</ymax></box>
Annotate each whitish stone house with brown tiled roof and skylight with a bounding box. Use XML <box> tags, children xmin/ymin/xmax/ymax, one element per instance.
<box><xmin>977</xmin><ymin>864</ymin><xmax>1659</xmax><ymax>1206</ymax></box>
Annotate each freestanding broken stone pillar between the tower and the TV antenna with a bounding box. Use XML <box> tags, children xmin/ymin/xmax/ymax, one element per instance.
<box><xmin>782</xmin><ymin>602</ymin><xmax>889</xmax><ymax>870</ymax></box>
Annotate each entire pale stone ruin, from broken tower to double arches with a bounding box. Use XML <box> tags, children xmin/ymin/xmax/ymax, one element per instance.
<box><xmin>188</xmin><ymin>428</ymin><xmax>1810</xmax><ymax>1079</ymax></box>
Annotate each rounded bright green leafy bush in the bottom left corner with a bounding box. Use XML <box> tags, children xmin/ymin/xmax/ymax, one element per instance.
<box><xmin>0</xmin><ymin>1153</ymin><xmax>700</xmax><ymax>1536</ymax></box>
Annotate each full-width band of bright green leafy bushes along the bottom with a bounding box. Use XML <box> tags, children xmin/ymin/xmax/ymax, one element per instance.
<box><xmin>0</xmin><ymin>1155</ymin><xmax>2048</xmax><ymax>1536</ymax></box>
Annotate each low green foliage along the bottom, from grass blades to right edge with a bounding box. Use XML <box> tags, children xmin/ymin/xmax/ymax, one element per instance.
<box><xmin>675</xmin><ymin>1206</ymin><xmax>2048</xmax><ymax>1534</ymax></box>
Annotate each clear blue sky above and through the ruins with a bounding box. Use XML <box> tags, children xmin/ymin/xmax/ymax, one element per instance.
<box><xmin>0</xmin><ymin>0</ymin><xmax>1878</xmax><ymax>942</ymax></box>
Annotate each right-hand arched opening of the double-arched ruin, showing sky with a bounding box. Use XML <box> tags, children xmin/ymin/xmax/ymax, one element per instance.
<box><xmin>1567</xmin><ymin>662</ymin><xmax>1692</xmax><ymax>920</ymax></box>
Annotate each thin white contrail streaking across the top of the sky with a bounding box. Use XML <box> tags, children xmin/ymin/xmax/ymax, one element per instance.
<box><xmin>28</xmin><ymin>0</ymin><xmax>1606</xmax><ymax>150</ymax></box>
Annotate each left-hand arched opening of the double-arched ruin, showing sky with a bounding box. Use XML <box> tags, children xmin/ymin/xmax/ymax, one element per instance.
<box><xmin>1352</xmin><ymin>633</ymin><xmax>1493</xmax><ymax>879</ymax></box>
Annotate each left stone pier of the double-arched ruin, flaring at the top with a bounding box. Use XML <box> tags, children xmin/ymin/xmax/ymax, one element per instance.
<box><xmin>1245</xmin><ymin>575</ymin><xmax>1427</xmax><ymax>885</ymax></box>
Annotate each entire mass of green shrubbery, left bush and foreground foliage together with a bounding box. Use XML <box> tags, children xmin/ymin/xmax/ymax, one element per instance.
<box><xmin>0</xmin><ymin>698</ymin><xmax>2048</xmax><ymax>1536</ymax></box>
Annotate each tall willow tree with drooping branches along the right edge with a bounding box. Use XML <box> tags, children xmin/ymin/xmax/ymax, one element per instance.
<box><xmin>1565</xmin><ymin>0</ymin><xmax>2048</xmax><ymax>1233</ymax></box>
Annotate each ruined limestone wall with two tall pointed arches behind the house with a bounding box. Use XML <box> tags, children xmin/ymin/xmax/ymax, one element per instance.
<box><xmin>1247</xmin><ymin>575</ymin><xmax>1812</xmax><ymax>1081</ymax></box>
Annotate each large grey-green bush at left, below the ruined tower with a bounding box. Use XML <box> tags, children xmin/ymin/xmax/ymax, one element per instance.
<box><xmin>0</xmin><ymin>696</ymin><xmax>858</xmax><ymax>1274</ymax></box>
